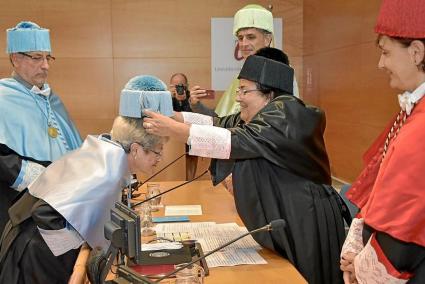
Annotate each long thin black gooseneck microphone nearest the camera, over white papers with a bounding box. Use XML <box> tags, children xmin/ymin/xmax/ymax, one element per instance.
<box><xmin>154</xmin><ymin>219</ymin><xmax>286</xmax><ymax>283</ymax></box>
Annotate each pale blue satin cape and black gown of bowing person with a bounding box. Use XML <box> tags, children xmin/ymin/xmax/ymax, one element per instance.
<box><xmin>0</xmin><ymin>135</ymin><xmax>132</xmax><ymax>284</ymax></box>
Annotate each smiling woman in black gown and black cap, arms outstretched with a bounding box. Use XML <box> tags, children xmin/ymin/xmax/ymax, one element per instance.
<box><xmin>144</xmin><ymin>48</ymin><xmax>344</xmax><ymax>283</ymax></box>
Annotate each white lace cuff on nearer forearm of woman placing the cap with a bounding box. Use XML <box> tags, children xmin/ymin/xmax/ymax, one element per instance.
<box><xmin>188</xmin><ymin>124</ymin><xmax>231</xmax><ymax>159</ymax></box>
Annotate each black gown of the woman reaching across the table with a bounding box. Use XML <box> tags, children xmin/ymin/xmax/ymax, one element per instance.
<box><xmin>210</xmin><ymin>95</ymin><xmax>345</xmax><ymax>284</ymax></box>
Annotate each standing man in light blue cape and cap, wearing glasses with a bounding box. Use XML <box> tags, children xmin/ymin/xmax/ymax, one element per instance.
<box><xmin>0</xmin><ymin>22</ymin><xmax>81</xmax><ymax>233</ymax></box>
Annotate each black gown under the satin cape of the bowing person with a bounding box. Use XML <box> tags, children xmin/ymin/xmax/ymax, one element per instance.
<box><xmin>0</xmin><ymin>192</ymin><xmax>79</xmax><ymax>284</ymax></box>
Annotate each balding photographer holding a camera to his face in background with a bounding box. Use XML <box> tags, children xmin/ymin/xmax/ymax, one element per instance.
<box><xmin>170</xmin><ymin>73</ymin><xmax>192</xmax><ymax>112</ymax></box>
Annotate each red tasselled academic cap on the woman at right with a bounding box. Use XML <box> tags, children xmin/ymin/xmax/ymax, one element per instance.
<box><xmin>375</xmin><ymin>0</ymin><xmax>425</xmax><ymax>38</ymax></box>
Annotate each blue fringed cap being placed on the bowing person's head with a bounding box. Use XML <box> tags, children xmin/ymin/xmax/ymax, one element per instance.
<box><xmin>119</xmin><ymin>75</ymin><xmax>174</xmax><ymax>118</ymax></box>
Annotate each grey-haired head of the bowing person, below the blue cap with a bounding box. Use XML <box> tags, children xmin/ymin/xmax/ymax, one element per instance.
<box><xmin>111</xmin><ymin>116</ymin><xmax>163</xmax><ymax>153</ymax></box>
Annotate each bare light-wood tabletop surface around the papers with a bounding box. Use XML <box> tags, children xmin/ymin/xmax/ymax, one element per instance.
<box><xmin>141</xmin><ymin>180</ymin><xmax>307</xmax><ymax>284</ymax></box>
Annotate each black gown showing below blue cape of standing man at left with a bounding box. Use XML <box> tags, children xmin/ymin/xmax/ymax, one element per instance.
<box><xmin>0</xmin><ymin>144</ymin><xmax>51</xmax><ymax>235</ymax></box>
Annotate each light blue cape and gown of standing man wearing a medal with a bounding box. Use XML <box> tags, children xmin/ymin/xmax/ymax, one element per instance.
<box><xmin>0</xmin><ymin>74</ymin><xmax>81</xmax><ymax>233</ymax></box>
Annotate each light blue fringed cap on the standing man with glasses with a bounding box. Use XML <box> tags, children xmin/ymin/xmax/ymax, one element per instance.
<box><xmin>6</xmin><ymin>22</ymin><xmax>52</xmax><ymax>54</ymax></box>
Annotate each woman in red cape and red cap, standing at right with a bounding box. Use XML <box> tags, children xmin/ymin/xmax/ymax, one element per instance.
<box><xmin>341</xmin><ymin>0</ymin><xmax>425</xmax><ymax>283</ymax></box>
